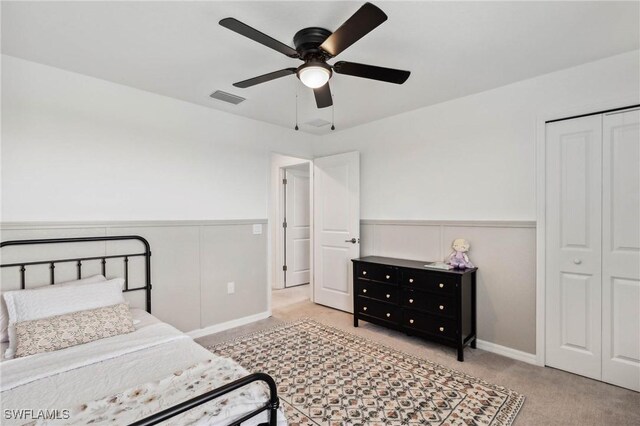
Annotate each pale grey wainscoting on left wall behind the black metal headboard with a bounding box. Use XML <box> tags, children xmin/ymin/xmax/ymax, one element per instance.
<box><xmin>1</xmin><ymin>219</ymin><xmax>268</xmax><ymax>332</ymax></box>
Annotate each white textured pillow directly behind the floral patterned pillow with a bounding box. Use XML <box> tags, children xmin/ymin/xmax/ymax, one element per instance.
<box><xmin>3</xmin><ymin>278</ymin><xmax>126</xmax><ymax>358</ymax></box>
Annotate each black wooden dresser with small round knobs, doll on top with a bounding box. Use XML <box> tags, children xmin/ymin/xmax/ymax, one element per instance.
<box><xmin>352</xmin><ymin>256</ymin><xmax>477</xmax><ymax>361</ymax></box>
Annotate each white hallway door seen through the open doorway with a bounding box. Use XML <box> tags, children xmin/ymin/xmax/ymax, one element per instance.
<box><xmin>285</xmin><ymin>164</ymin><xmax>311</xmax><ymax>287</ymax></box>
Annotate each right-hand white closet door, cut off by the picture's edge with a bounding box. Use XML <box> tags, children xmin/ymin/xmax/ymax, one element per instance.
<box><xmin>602</xmin><ymin>110</ymin><xmax>640</xmax><ymax>391</ymax></box>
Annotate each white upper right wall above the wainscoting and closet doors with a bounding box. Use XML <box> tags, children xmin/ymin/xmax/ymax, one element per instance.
<box><xmin>313</xmin><ymin>51</ymin><xmax>640</xmax><ymax>221</ymax></box>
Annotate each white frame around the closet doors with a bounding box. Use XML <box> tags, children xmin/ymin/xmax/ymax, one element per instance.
<box><xmin>535</xmin><ymin>96</ymin><xmax>639</xmax><ymax>367</ymax></box>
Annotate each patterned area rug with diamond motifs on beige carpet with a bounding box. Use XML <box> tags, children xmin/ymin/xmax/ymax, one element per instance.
<box><xmin>209</xmin><ymin>319</ymin><xmax>524</xmax><ymax>426</ymax></box>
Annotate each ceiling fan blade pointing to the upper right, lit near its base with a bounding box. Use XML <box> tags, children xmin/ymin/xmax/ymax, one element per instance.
<box><xmin>320</xmin><ymin>3</ymin><xmax>387</xmax><ymax>56</ymax></box>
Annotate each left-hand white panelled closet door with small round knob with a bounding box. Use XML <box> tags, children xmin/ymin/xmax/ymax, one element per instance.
<box><xmin>546</xmin><ymin>115</ymin><xmax>602</xmax><ymax>379</ymax></box>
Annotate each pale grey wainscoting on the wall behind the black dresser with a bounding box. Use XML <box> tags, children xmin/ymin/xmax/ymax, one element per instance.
<box><xmin>360</xmin><ymin>220</ymin><xmax>536</xmax><ymax>361</ymax></box>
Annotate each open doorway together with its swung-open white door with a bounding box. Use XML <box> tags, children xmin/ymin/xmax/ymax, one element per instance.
<box><xmin>269</xmin><ymin>152</ymin><xmax>360</xmax><ymax>313</ymax></box>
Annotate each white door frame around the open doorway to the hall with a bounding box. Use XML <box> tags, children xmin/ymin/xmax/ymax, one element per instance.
<box><xmin>267</xmin><ymin>152</ymin><xmax>313</xmax><ymax>315</ymax></box>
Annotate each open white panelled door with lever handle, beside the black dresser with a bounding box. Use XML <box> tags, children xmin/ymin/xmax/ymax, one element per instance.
<box><xmin>313</xmin><ymin>152</ymin><xmax>360</xmax><ymax>312</ymax></box>
